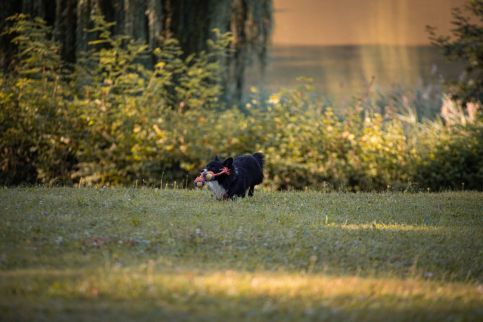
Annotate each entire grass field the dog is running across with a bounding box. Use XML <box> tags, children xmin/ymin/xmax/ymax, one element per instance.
<box><xmin>0</xmin><ymin>188</ymin><xmax>483</xmax><ymax>321</ymax></box>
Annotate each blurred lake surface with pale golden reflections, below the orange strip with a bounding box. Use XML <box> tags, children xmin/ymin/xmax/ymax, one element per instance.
<box><xmin>247</xmin><ymin>45</ymin><xmax>463</xmax><ymax>102</ymax></box>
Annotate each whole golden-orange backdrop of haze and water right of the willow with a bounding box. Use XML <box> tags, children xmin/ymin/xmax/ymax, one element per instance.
<box><xmin>255</xmin><ymin>0</ymin><xmax>466</xmax><ymax>105</ymax></box>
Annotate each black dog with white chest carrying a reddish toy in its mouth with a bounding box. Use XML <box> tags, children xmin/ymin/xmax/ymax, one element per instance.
<box><xmin>202</xmin><ymin>153</ymin><xmax>264</xmax><ymax>199</ymax></box>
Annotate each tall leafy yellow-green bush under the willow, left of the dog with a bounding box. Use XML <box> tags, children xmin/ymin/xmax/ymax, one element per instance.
<box><xmin>72</xmin><ymin>11</ymin><xmax>230</xmax><ymax>184</ymax></box>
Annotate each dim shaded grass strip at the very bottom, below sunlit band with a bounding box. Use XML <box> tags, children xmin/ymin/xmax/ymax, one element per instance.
<box><xmin>0</xmin><ymin>298</ymin><xmax>483</xmax><ymax>321</ymax></box>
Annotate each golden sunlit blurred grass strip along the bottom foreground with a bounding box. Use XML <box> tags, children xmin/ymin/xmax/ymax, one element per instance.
<box><xmin>0</xmin><ymin>270</ymin><xmax>483</xmax><ymax>321</ymax></box>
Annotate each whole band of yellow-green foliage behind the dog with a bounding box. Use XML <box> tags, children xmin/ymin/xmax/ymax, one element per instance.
<box><xmin>0</xmin><ymin>15</ymin><xmax>483</xmax><ymax>190</ymax></box>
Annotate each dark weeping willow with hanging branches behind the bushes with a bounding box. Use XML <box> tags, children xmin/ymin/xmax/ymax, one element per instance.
<box><xmin>0</xmin><ymin>0</ymin><xmax>273</xmax><ymax>103</ymax></box>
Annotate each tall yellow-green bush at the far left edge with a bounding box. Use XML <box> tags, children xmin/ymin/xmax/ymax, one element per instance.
<box><xmin>0</xmin><ymin>15</ymin><xmax>76</xmax><ymax>184</ymax></box>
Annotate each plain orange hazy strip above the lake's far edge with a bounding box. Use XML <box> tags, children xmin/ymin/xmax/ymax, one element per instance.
<box><xmin>273</xmin><ymin>0</ymin><xmax>467</xmax><ymax>45</ymax></box>
